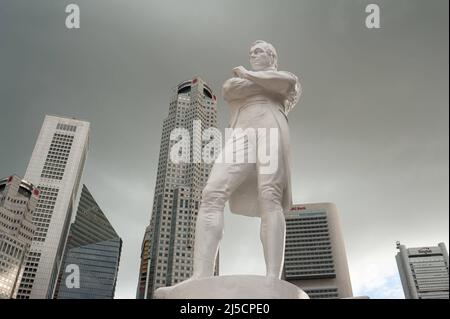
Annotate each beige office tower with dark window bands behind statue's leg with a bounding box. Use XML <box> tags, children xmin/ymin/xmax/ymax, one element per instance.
<box><xmin>283</xmin><ymin>203</ymin><xmax>353</xmax><ymax>299</ymax></box>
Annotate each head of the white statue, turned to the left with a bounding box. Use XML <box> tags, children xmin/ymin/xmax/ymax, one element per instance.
<box><xmin>250</xmin><ymin>40</ymin><xmax>278</xmax><ymax>71</ymax></box>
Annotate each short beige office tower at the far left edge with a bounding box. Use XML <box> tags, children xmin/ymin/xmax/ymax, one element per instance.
<box><xmin>0</xmin><ymin>175</ymin><xmax>39</xmax><ymax>299</ymax></box>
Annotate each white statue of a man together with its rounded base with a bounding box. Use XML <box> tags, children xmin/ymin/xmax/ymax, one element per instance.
<box><xmin>154</xmin><ymin>41</ymin><xmax>309</xmax><ymax>299</ymax></box>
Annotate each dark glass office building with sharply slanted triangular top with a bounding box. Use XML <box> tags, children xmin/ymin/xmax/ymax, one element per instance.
<box><xmin>54</xmin><ymin>185</ymin><xmax>122</xmax><ymax>299</ymax></box>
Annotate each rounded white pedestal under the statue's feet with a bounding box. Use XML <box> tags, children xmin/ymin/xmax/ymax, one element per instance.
<box><xmin>154</xmin><ymin>275</ymin><xmax>309</xmax><ymax>299</ymax></box>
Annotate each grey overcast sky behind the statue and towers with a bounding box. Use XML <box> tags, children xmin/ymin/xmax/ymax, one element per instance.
<box><xmin>0</xmin><ymin>0</ymin><xmax>449</xmax><ymax>298</ymax></box>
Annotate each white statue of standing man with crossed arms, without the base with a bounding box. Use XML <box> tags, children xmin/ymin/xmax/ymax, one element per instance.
<box><xmin>191</xmin><ymin>41</ymin><xmax>301</xmax><ymax>279</ymax></box>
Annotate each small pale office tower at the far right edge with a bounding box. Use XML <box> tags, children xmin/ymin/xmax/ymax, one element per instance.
<box><xmin>395</xmin><ymin>242</ymin><xmax>448</xmax><ymax>299</ymax></box>
